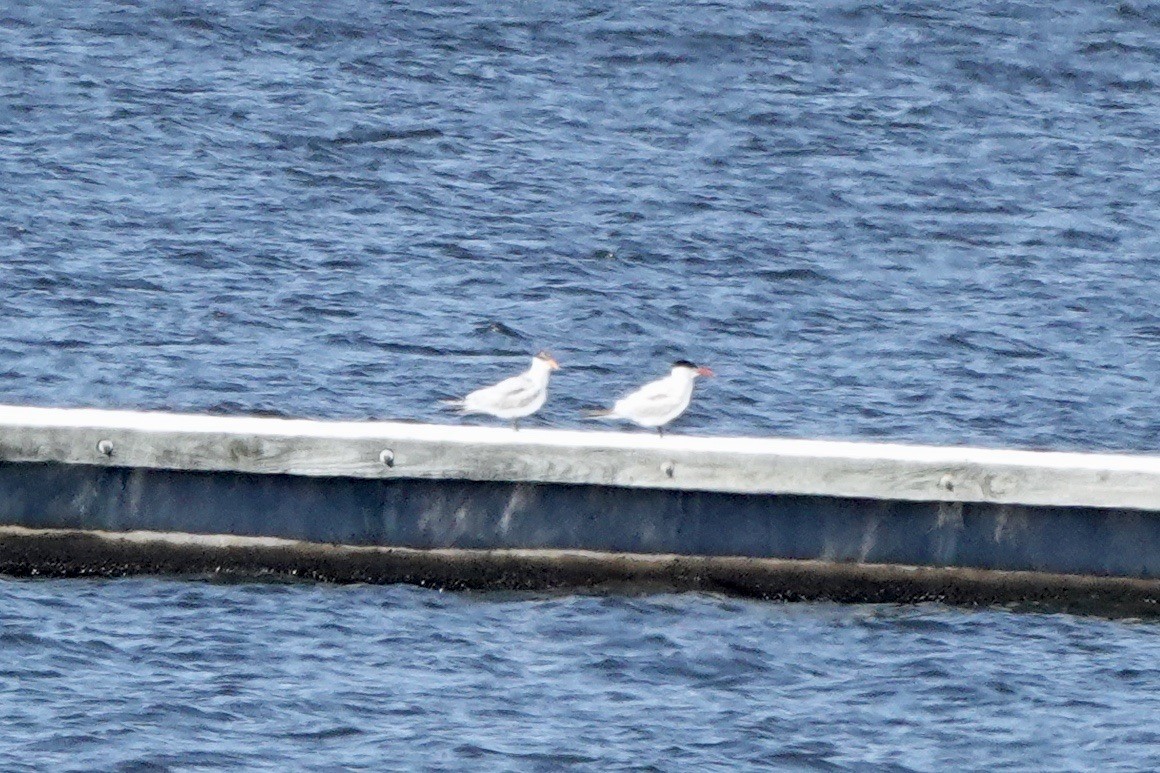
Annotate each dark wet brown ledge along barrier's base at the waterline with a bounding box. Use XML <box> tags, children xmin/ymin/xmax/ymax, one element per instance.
<box><xmin>0</xmin><ymin>527</ymin><xmax>1160</xmax><ymax>616</ymax></box>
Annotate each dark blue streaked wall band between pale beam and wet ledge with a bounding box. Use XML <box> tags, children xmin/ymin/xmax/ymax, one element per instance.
<box><xmin>0</xmin><ymin>463</ymin><xmax>1160</xmax><ymax>578</ymax></box>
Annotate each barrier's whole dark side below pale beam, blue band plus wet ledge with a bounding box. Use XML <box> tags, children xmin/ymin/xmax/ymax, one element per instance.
<box><xmin>0</xmin><ymin>463</ymin><xmax>1160</xmax><ymax>604</ymax></box>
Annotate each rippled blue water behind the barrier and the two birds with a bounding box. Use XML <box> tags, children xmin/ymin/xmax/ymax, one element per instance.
<box><xmin>0</xmin><ymin>0</ymin><xmax>1160</xmax><ymax>449</ymax></box>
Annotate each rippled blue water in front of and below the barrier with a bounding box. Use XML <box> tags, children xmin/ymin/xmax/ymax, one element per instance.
<box><xmin>0</xmin><ymin>579</ymin><xmax>1160</xmax><ymax>771</ymax></box>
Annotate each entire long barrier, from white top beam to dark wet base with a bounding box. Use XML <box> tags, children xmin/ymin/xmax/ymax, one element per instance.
<box><xmin>0</xmin><ymin>406</ymin><xmax>1160</xmax><ymax>607</ymax></box>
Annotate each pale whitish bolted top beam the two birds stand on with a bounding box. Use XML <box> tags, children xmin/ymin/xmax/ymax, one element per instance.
<box><xmin>0</xmin><ymin>406</ymin><xmax>1160</xmax><ymax>511</ymax></box>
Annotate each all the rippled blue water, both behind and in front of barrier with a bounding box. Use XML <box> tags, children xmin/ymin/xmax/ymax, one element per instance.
<box><xmin>0</xmin><ymin>0</ymin><xmax>1160</xmax><ymax>771</ymax></box>
